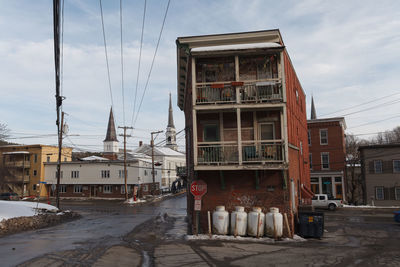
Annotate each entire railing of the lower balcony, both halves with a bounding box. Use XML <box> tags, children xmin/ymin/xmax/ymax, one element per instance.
<box><xmin>197</xmin><ymin>140</ymin><xmax>285</xmax><ymax>165</ymax></box>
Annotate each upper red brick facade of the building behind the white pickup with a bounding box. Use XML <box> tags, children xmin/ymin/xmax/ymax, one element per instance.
<box><xmin>308</xmin><ymin>121</ymin><xmax>346</xmax><ymax>172</ymax></box>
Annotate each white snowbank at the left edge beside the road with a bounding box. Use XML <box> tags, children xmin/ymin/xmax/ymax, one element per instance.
<box><xmin>0</xmin><ymin>200</ymin><xmax>58</xmax><ymax>222</ymax></box>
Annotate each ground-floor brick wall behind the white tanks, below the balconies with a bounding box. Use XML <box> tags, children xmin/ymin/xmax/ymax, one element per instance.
<box><xmin>195</xmin><ymin>170</ymin><xmax>293</xmax><ymax>236</ymax></box>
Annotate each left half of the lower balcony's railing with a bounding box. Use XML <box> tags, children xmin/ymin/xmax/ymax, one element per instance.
<box><xmin>197</xmin><ymin>142</ymin><xmax>239</xmax><ymax>165</ymax></box>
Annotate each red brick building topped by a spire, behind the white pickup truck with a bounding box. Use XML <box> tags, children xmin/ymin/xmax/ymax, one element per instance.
<box><xmin>307</xmin><ymin>105</ymin><xmax>346</xmax><ymax>200</ymax></box>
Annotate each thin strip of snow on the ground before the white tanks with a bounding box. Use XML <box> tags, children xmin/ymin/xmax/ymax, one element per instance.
<box><xmin>185</xmin><ymin>235</ymin><xmax>307</xmax><ymax>244</ymax></box>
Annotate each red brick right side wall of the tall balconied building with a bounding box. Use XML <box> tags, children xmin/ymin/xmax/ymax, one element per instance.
<box><xmin>283</xmin><ymin>50</ymin><xmax>310</xmax><ymax>201</ymax></box>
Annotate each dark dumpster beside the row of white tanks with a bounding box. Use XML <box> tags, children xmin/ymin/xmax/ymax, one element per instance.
<box><xmin>298</xmin><ymin>212</ymin><xmax>324</xmax><ymax>238</ymax></box>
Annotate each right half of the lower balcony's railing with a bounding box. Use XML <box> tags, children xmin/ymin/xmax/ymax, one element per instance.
<box><xmin>242</xmin><ymin>140</ymin><xmax>284</xmax><ymax>163</ymax></box>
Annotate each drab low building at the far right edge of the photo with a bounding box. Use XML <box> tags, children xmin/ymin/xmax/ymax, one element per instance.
<box><xmin>359</xmin><ymin>144</ymin><xmax>400</xmax><ymax>206</ymax></box>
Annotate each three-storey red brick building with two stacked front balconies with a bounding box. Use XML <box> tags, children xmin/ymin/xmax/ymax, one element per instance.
<box><xmin>176</xmin><ymin>30</ymin><xmax>312</xmax><ymax>232</ymax></box>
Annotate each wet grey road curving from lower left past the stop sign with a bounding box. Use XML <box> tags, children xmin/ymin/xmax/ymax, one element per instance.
<box><xmin>0</xmin><ymin>195</ymin><xmax>186</xmax><ymax>266</ymax></box>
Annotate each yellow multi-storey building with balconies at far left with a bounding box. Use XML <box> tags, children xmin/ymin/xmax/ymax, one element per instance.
<box><xmin>0</xmin><ymin>144</ymin><xmax>72</xmax><ymax>197</ymax></box>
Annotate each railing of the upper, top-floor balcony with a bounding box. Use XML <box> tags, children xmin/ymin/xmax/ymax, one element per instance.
<box><xmin>196</xmin><ymin>79</ymin><xmax>283</xmax><ymax>104</ymax></box>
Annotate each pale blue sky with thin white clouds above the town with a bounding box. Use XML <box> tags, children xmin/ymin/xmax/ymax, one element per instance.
<box><xmin>0</xmin><ymin>0</ymin><xmax>400</xmax><ymax>151</ymax></box>
